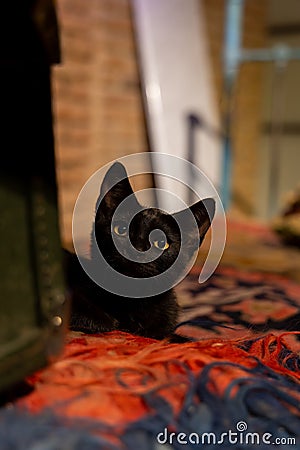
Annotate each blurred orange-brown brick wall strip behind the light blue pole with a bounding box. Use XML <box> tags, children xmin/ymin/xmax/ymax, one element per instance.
<box><xmin>204</xmin><ymin>0</ymin><xmax>268</xmax><ymax>215</ymax></box>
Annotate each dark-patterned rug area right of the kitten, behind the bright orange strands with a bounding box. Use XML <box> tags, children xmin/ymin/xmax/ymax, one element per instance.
<box><xmin>178</xmin><ymin>267</ymin><xmax>300</xmax><ymax>344</ymax></box>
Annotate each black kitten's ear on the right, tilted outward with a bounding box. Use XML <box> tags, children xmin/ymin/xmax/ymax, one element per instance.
<box><xmin>174</xmin><ymin>198</ymin><xmax>216</xmax><ymax>243</ymax></box>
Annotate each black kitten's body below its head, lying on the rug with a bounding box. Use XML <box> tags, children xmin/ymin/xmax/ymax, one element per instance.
<box><xmin>67</xmin><ymin>248</ymin><xmax>179</xmax><ymax>339</ymax></box>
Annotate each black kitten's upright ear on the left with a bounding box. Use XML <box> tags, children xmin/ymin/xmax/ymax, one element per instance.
<box><xmin>97</xmin><ymin>162</ymin><xmax>137</xmax><ymax>210</ymax></box>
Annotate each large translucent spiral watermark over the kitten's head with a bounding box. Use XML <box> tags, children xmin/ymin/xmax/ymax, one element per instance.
<box><xmin>72</xmin><ymin>152</ymin><xmax>226</xmax><ymax>298</ymax></box>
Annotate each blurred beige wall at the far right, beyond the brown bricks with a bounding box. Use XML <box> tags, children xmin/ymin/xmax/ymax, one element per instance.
<box><xmin>257</xmin><ymin>0</ymin><xmax>300</xmax><ymax>219</ymax></box>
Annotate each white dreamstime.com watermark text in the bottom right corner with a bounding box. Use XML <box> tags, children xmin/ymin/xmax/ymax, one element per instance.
<box><xmin>156</xmin><ymin>420</ymin><xmax>296</xmax><ymax>448</ymax></box>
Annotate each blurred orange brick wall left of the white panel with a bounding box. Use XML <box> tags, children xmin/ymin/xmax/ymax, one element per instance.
<box><xmin>53</xmin><ymin>0</ymin><xmax>147</xmax><ymax>243</ymax></box>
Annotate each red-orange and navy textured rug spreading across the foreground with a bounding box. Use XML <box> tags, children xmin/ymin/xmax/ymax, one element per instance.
<box><xmin>0</xmin><ymin>221</ymin><xmax>300</xmax><ymax>450</ymax></box>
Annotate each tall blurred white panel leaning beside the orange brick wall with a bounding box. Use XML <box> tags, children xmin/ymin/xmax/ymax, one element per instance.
<box><xmin>132</xmin><ymin>0</ymin><xmax>221</xmax><ymax>209</ymax></box>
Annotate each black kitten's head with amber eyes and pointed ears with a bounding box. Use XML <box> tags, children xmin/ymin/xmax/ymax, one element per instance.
<box><xmin>92</xmin><ymin>162</ymin><xmax>215</xmax><ymax>278</ymax></box>
